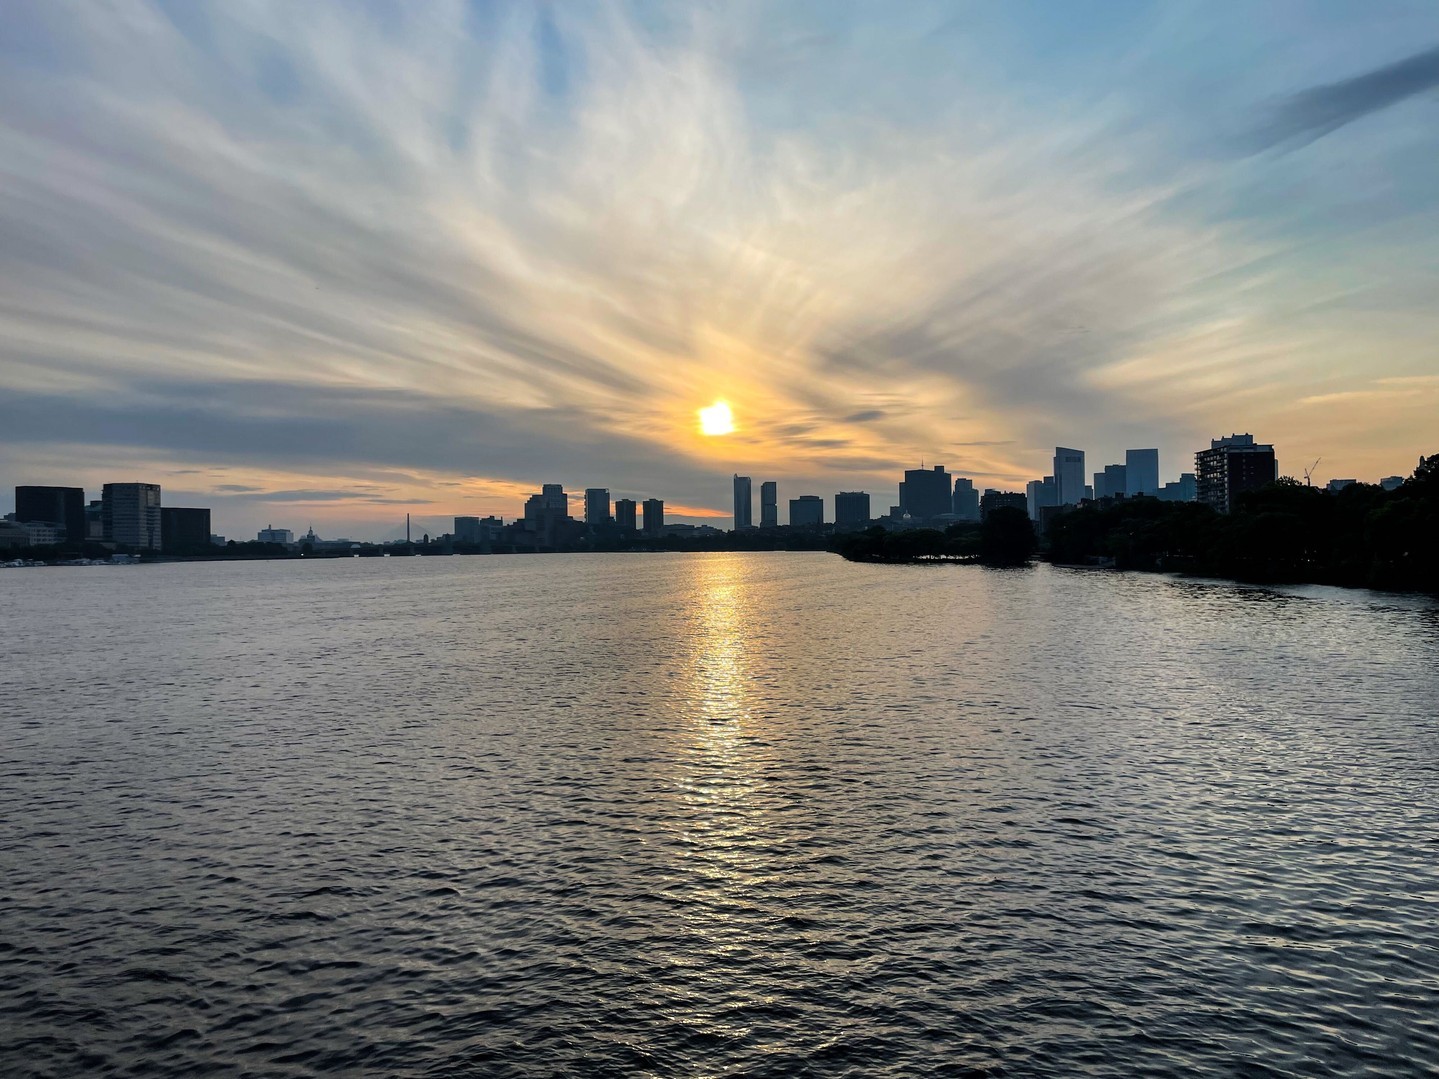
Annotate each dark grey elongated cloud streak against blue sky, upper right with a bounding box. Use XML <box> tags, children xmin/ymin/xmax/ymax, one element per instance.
<box><xmin>1253</xmin><ymin>46</ymin><xmax>1439</xmax><ymax>150</ymax></box>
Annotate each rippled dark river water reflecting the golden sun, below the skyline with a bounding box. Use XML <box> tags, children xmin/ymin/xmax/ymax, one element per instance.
<box><xmin>0</xmin><ymin>554</ymin><xmax>1439</xmax><ymax>1076</ymax></box>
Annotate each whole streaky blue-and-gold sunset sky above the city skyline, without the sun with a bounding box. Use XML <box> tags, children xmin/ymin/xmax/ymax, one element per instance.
<box><xmin>0</xmin><ymin>0</ymin><xmax>1439</xmax><ymax>538</ymax></box>
